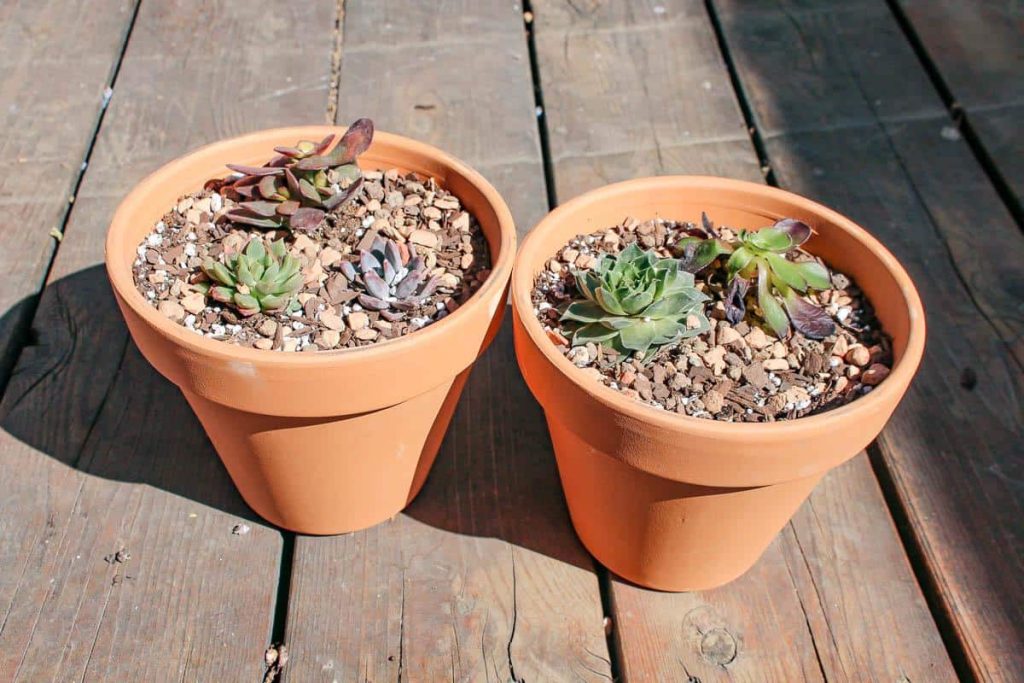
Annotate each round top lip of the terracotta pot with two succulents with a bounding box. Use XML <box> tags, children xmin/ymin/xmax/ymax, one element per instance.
<box><xmin>511</xmin><ymin>175</ymin><xmax>926</xmax><ymax>438</ymax></box>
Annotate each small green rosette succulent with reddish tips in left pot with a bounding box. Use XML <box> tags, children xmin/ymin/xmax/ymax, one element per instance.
<box><xmin>203</xmin><ymin>238</ymin><xmax>302</xmax><ymax>315</ymax></box>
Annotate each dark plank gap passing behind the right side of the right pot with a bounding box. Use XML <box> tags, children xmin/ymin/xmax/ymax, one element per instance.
<box><xmin>705</xmin><ymin>0</ymin><xmax>977</xmax><ymax>681</ymax></box>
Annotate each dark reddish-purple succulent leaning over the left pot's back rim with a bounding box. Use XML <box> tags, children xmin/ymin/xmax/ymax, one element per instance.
<box><xmin>206</xmin><ymin>119</ymin><xmax>374</xmax><ymax>230</ymax></box>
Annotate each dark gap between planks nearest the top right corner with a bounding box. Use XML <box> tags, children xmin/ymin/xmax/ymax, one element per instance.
<box><xmin>886</xmin><ymin>0</ymin><xmax>1024</xmax><ymax>230</ymax></box>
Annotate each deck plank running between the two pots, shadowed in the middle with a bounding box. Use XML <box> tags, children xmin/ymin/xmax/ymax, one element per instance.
<box><xmin>286</xmin><ymin>0</ymin><xmax>610</xmax><ymax>682</ymax></box>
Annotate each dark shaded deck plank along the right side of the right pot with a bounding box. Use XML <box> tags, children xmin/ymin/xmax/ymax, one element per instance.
<box><xmin>721</xmin><ymin>2</ymin><xmax>1024</xmax><ymax>680</ymax></box>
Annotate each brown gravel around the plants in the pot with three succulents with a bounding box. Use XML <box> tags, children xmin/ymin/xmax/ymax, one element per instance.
<box><xmin>133</xmin><ymin>170</ymin><xmax>490</xmax><ymax>351</ymax></box>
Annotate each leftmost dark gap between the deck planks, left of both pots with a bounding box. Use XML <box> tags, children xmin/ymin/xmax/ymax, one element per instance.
<box><xmin>0</xmin><ymin>0</ymin><xmax>142</xmax><ymax>396</ymax></box>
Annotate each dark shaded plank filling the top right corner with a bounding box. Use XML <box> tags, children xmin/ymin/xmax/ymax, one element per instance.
<box><xmin>898</xmin><ymin>0</ymin><xmax>1024</xmax><ymax>206</ymax></box>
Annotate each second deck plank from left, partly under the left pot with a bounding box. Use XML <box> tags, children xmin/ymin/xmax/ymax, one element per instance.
<box><xmin>0</xmin><ymin>0</ymin><xmax>335</xmax><ymax>681</ymax></box>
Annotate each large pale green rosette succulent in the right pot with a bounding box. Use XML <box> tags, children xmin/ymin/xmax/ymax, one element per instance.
<box><xmin>561</xmin><ymin>244</ymin><xmax>710</xmax><ymax>359</ymax></box>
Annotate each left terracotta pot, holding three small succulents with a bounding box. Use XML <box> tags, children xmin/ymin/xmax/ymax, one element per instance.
<box><xmin>106</xmin><ymin>126</ymin><xmax>515</xmax><ymax>533</ymax></box>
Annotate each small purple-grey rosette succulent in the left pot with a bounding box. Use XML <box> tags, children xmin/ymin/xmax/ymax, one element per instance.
<box><xmin>340</xmin><ymin>234</ymin><xmax>440</xmax><ymax>313</ymax></box>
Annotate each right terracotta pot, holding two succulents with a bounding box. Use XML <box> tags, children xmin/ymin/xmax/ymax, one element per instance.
<box><xmin>512</xmin><ymin>176</ymin><xmax>925</xmax><ymax>591</ymax></box>
